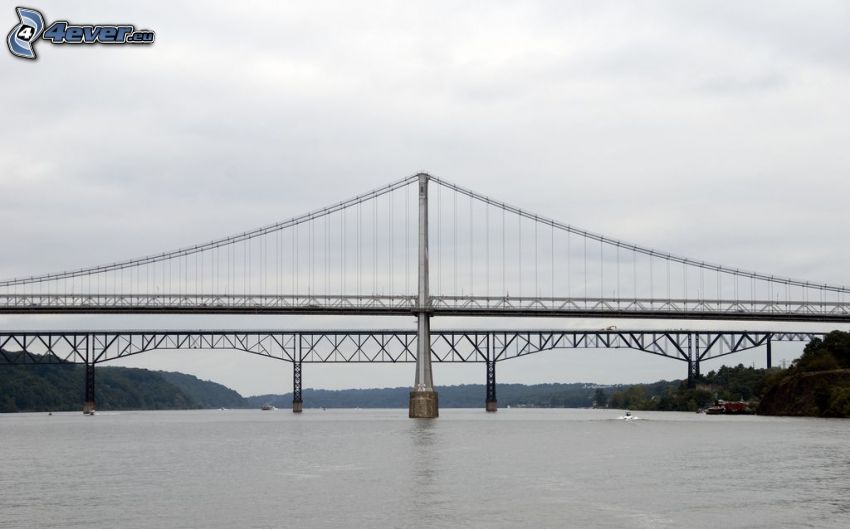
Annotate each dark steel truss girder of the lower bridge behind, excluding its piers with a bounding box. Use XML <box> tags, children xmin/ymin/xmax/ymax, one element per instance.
<box><xmin>0</xmin><ymin>330</ymin><xmax>824</xmax><ymax>365</ymax></box>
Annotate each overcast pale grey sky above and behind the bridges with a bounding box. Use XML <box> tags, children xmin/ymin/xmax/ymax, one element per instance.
<box><xmin>0</xmin><ymin>0</ymin><xmax>850</xmax><ymax>395</ymax></box>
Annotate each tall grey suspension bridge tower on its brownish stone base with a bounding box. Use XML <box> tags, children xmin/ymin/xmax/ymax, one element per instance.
<box><xmin>409</xmin><ymin>173</ymin><xmax>440</xmax><ymax>419</ymax></box>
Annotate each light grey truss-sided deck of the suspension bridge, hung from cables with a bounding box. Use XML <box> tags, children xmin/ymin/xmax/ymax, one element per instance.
<box><xmin>0</xmin><ymin>294</ymin><xmax>850</xmax><ymax>322</ymax></box>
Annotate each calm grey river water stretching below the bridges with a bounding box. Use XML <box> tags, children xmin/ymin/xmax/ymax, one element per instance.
<box><xmin>0</xmin><ymin>409</ymin><xmax>850</xmax><ymax>529</ymax></box>
